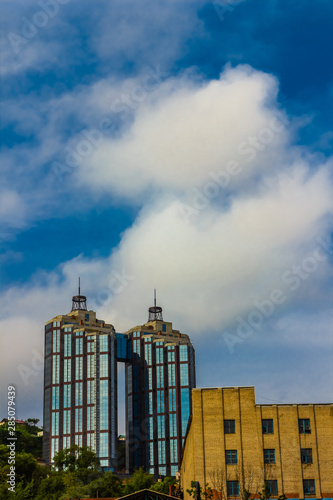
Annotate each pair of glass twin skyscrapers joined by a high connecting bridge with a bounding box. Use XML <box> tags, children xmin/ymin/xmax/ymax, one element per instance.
<box><xmin>43</xmin><ymin>292</ymin><xmax>195</xmax><ymax>476</ymax></box>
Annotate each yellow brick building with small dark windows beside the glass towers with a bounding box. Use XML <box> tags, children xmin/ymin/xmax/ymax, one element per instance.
<box><xmin>180</xmin><ymin>387</ymin><xmax>333</xmax><ymax>500</ymax></box>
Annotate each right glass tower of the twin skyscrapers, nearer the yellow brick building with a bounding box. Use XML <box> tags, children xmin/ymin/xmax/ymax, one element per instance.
<box><xmin>125</xmin><ymin>300</ymin><xmax>195</xmax><ymax>476</ymax></box>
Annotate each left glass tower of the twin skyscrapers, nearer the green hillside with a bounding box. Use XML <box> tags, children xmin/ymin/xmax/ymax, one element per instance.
<box><xmin>43</xmin><ymin>294</ymin><xmax>117</xmax><ymax>469</ymax></box>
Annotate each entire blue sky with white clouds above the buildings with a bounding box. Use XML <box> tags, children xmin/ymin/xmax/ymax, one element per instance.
<box><xmin>0</xmin><ymin>0</ymin><xmax>333</xmax><ymax>428</ymax></box>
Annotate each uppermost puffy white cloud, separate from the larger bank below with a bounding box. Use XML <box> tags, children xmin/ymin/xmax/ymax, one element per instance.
<box><xmin>78</xmin><ymin>66</ymin><xmax>294</xmax><ymax>200</ymax></box>
